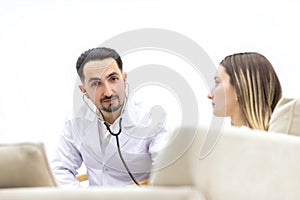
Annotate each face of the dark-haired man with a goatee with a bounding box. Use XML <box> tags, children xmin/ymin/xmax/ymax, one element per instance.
<box><xmin>80</xmin><ymin>58</ymin><xmax>127</xmax><ymax>114</ymax></box>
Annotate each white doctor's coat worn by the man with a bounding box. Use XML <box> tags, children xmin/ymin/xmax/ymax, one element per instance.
<box><xmin>51</xmin><ymin>100</ymin><xmax>169</xmax><ymax>187</ymax></box>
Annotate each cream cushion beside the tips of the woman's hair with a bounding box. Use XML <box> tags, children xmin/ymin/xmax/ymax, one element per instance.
<box><xmin>269</xmin><ymin>98</ymin><xmax>300</xmax><ymax>136</ymax></box>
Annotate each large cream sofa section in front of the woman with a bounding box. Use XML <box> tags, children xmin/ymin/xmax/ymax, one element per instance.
<box><xmin>149</xmin><ymin>127</ymin><xmax>300</xmax><ymax>200</ymax></box>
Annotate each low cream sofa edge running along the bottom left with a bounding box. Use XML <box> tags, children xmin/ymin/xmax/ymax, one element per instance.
<box><xmin>0</xmin><ymin>186</ymin><xmax>205</xmax><ymax>200</ymax></box>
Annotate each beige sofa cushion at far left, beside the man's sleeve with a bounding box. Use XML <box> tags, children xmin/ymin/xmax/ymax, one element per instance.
<box><xmin>0</xmin><ymin>143</ymin><xmax>56</xmax><ymax>188</ymax></box>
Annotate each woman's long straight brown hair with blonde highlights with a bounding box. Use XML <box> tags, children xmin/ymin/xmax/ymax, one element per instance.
<box><xmin>220</xmin><ymin>52</ymin><xmax>282</xmax><ymax>130</ymax></box>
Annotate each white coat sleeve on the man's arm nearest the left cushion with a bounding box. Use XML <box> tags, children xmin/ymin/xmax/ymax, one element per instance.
<box><xmin>51</xmin><ymin>121</ymin><xmax>82</xmax><ymax>187</ymax></box>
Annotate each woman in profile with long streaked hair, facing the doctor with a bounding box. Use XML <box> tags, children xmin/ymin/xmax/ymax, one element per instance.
<box><xmin>208</xmin><ymin>52</ymin><xmax>282</xmax><ymax>130</ymax></box>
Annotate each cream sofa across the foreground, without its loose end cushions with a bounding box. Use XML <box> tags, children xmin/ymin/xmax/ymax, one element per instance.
<box><xmin>0</xmin><ymin>97</ymin><xmax>300</xmax><ymax>200</ymax></box>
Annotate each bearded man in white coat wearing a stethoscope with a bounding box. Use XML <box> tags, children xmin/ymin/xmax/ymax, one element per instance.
<box><xmin>52</xmin><ymin>47</ymin><xmax>171</xmax><ymax>187</ymax></box>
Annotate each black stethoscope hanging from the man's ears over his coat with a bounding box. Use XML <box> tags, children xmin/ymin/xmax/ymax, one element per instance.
<box><xmin>82</xmin><ymin>94</ymin><xmax>140</xmax><ymax>186</ymax></box>
